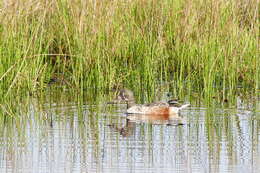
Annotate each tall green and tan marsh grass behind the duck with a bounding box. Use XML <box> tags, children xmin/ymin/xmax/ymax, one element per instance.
<box><xmin>0</xmin><ymin>0</ymin><xmax>260</xmax><ymax>98</ymax></box>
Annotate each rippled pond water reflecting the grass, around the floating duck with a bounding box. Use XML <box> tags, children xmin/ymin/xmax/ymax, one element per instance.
<box><xmin>0</xmin><ymin>91</ymin><xmax>260</xmax><ymax>173</ymax></box>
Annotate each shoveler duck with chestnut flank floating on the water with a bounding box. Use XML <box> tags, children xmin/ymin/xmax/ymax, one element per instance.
<box><xmin>117</xmin><ymin>89</ymin><xmax>190</xmax><ymax>115</ymax></box>
